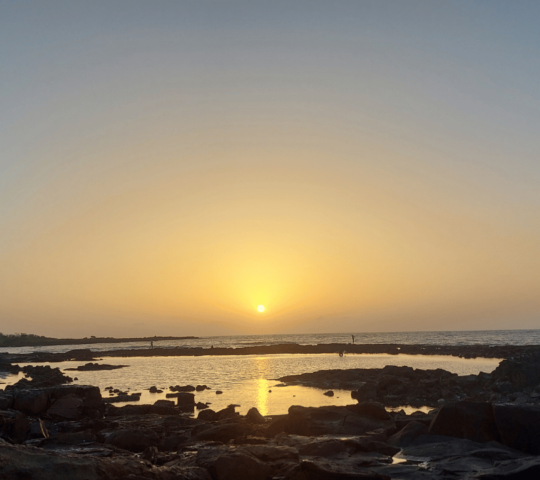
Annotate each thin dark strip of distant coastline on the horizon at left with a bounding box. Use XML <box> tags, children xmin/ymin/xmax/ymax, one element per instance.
<box><xmin>0</xmin><ymin>333</ymin><xmax>199</xmax><ymax>347</ymax></box>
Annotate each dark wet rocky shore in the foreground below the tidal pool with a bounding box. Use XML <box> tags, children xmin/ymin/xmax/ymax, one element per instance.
<box><xmin>0</xmin><ymin>352</ymin><xmax>540</xmax><ymax>480</ymax></box>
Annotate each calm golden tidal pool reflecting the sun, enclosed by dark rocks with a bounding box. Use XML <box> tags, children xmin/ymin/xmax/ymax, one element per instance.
<box><xmin>3</xmin><ymin>354</ymin><xmax>500</xmax><ymax>415</ymax></box>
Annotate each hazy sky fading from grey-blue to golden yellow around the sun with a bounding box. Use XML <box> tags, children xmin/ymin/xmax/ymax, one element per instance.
<box><xmin>0</xmin><ymin>0</ymin><xmax>540</xmax><ymax>337</ymax></box>
